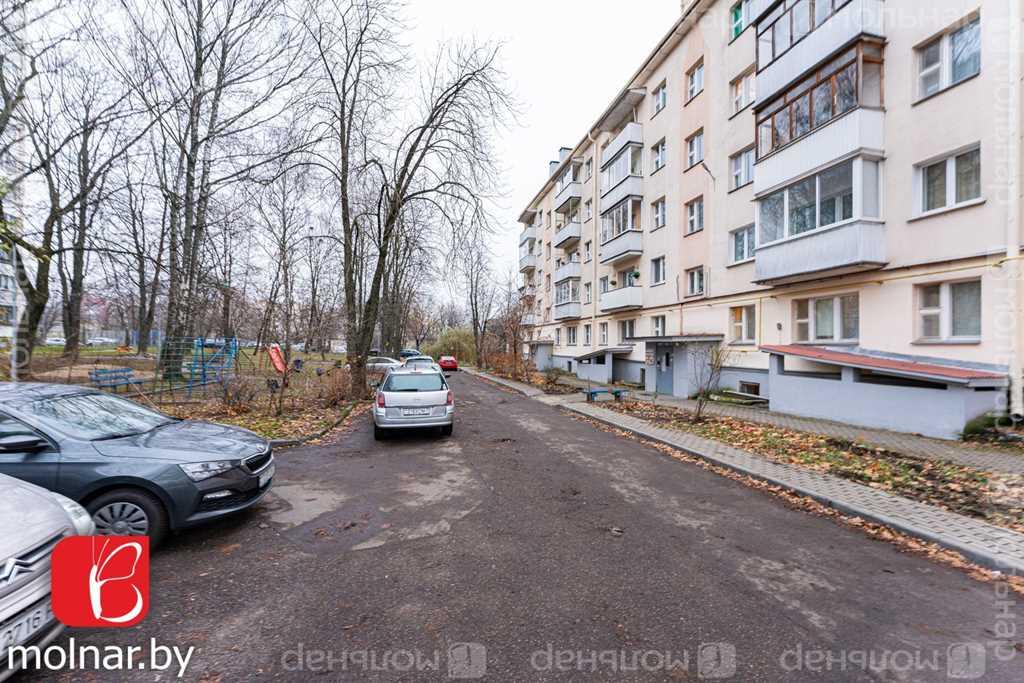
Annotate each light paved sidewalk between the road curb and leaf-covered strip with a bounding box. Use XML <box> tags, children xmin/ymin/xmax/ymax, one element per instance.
<box><xmin>563</xmin><ymin>401</ymin><xmax>1024</xmax><ymax>575</ymax></box>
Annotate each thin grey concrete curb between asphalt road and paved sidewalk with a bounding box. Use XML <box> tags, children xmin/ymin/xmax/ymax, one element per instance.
<box><xmin>562</xmin><ymin>404</ymin><xmax>1024</xmax><ymax>575</ymax></box>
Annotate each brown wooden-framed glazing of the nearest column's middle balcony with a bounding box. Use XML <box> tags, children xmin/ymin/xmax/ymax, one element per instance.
<box><xmin>757</xmin><ymin>41</ymin><xmax>883</xmax><ymax>158</ymax></box>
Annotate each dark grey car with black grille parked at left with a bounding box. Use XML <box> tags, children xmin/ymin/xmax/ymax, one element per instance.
<box><xmin>0</xmin><ymin>382</ymin><xmax>274</xmax><ymax>547</ymax></box>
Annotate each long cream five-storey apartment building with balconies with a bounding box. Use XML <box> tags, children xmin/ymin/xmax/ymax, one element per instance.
<box><xmin>519</xmin><ymin>0</ymin><xmax>1024</xmax><ymax>437</ymax></box>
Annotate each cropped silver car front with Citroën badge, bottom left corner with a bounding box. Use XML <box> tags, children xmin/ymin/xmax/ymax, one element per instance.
<box><xmin>0</xmin><ymin>474</ymin><xmax>94</xmax><ymax>681</ymax></box>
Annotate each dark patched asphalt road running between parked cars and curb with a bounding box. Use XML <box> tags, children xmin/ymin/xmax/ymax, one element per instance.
<box><xmin>27</xmin><ymin>375</ymin><xmax>1024</xmax><ymax>682</ymax></box>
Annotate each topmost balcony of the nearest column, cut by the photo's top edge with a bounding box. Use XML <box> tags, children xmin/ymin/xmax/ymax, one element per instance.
<box><xmin>757</xmin><ymin>0</ymin><xmax>886</xmax><ymax>101</ymax></box>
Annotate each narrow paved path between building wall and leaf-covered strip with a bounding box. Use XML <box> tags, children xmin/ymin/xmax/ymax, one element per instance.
<box><xmin>562</xmin><ymin>377</ymin><xmax>1024</xmax><ymax>474</ymax></box>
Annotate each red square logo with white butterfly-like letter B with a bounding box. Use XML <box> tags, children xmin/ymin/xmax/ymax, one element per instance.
<box><xmin>50</xmin><ymin>536</ymin><xmax>150</xmax><ymax>629</ymax></box>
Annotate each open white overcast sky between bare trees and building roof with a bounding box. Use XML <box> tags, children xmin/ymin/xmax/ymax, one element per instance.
<box><xmin>408</xmin><ymin>0</ymin><xmax>680</xmax><ymax>274</ymax></box>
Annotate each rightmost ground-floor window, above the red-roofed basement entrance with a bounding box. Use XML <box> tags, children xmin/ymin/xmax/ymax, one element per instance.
<box><xmin>918</xmin><ymin>280</ymin><xmax>981</xmax><ymax>341</ymax></box>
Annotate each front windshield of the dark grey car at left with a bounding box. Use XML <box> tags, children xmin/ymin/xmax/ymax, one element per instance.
<box><xmin>17</xmin><ymin>393</ymin><xmax>175</xmax><ymax>440</ymax></box>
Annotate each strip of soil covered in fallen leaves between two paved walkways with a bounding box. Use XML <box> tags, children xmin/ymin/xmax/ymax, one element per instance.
<box><xmin>601</xmin><ymin>401</ymin><xmax>1024</xmax><ymax>532</ymax></box>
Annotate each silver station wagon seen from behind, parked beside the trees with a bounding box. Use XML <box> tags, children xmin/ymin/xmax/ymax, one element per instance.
<box><xmin>373</xmin><ymin>368</ymin><xmax>455</xmax><ymax>440</ymax></box>
